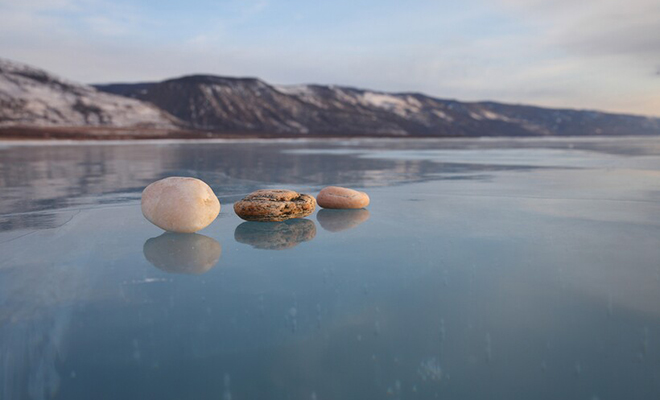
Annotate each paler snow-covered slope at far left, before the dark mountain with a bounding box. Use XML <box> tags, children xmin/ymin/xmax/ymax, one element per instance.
<box><xmin>0</xmin><ymin>59</ymin><xmax>181</xmax><ymax>129</ymax></box>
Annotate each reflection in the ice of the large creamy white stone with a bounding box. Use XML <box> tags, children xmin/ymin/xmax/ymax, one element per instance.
<box><xmin>143</xmin><ymin>232</ymin><xmax>222</xmax><ymax>275</ymax></box>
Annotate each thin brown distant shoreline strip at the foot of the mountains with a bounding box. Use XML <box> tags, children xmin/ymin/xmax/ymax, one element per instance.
<box><xmin>0</xmin><ymin>126</ymin><xmax>660</xmax><ymax>142</ymax></box>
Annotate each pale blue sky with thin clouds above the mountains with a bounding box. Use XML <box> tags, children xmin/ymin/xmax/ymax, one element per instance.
<box><xmin>0</xmin><ymin>0</ymin><xmax>660</xmax><ymax>116</ymax></box>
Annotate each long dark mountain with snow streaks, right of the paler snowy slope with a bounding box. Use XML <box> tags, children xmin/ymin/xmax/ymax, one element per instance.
<box><xmin>96</xmin><ymin>75</ymin><xmax>660</xmax><ymax>136</ymax></box>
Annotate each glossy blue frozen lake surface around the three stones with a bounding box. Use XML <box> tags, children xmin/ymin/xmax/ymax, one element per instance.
<box><xmin>0</xmin><ymin>137</ymin><xmax>660</xmax><ymax>400</ymax></box>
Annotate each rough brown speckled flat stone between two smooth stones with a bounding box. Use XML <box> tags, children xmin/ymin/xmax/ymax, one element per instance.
<box><xmin>234</xmin><ymin>189</ymin><xmax>316</xmax><ymax>222</ymax></box>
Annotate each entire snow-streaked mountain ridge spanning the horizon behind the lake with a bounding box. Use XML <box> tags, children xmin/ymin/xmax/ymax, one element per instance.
<box><xmin>0</xmin><ymin>58</ymin><xmax>660</xmax><ymax>137</ymax></box>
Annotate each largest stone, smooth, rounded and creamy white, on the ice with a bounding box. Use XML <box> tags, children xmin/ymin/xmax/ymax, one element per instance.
<box><xmin>142</xmin><ymin>176</ymin><xmax>220</xmax><ymax>233</ymax></box>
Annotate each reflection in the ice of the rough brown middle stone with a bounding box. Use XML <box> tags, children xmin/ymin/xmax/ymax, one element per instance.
<box><xmin>234</xmin><ymin>218</ymin><xmax>316</xmax><ymax>250</ymax></box>
